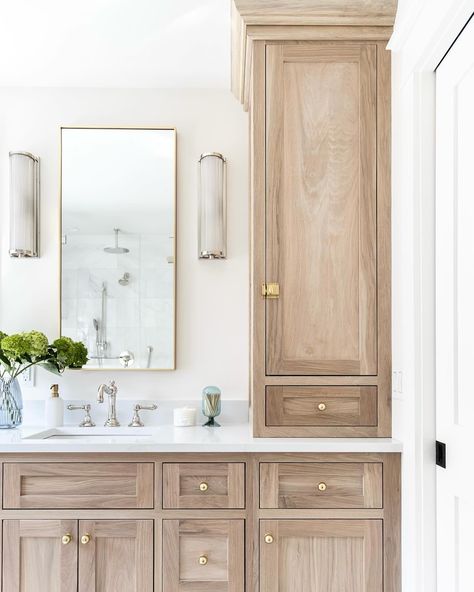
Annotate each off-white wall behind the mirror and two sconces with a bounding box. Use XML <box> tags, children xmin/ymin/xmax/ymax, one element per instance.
<box><xmin>0</xmin><ymin>88</ymin><xmax>249</xmax><ymax>400</ymax></box>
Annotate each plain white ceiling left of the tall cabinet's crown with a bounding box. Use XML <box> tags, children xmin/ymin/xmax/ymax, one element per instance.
<box><xmin>0</xmin><ymin>0</ymin><xmax>230</xmax><ymax>88</ymax></box>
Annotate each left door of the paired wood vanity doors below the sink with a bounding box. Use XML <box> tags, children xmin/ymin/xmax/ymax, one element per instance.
<box><xmin>2</xmin><ymin>520</ymin><xmax>77</xmax><ymax>592</ymax></box>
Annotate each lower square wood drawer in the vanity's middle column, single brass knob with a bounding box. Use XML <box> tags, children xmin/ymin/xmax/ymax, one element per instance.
<box><xmin>163</xmin><ymin>520</ymin><xmax>244</xmax><ymax>592</ymax></box>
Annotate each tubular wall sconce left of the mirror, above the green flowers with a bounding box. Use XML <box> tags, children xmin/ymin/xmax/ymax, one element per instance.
<box><xmin>10</xmin><ymin>152</ymin><xmax>39</xmax><ymax>257</ymax></box>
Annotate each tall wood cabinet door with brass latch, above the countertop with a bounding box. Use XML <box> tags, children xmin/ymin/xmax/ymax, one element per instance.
<box><xmin>265</xmin><ymin>42</ymin><xmax>377</xmax><ymax>376</ymax></box>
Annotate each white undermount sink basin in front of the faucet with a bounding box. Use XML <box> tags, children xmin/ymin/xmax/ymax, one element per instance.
<box><xmin>23</xmin><ymin>427</ymin><xmax>153</xmax><ymax>442</ymax></box>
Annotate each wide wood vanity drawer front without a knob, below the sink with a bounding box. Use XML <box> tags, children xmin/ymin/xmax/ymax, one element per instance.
<box><xmin>3</xmin><ymin>462</ymin><xmax>154</xmax><ymax>509</ymax></box>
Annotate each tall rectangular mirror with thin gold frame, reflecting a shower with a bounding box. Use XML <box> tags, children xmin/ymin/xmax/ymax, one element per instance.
<box><xmin>61</xmin><ymin>127</ymin><xmax>176</xmax><ymax>370</ymax></box>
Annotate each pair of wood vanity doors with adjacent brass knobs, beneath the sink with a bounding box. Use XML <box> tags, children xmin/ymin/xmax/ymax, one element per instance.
<box><xmin>3</xmin><ymin>519</ymin><xmax>153</xmax><ymax>592</ymax></box>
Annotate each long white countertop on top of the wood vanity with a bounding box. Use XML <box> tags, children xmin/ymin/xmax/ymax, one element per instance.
<box><xmin>0</xmin><ymin>423</ymin><xmax>402</xmax><ymax>454</ymax></box>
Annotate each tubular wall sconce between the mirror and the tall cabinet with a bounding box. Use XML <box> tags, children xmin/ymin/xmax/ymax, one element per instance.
<box><xmin>199</xmin><ymin>152</ymin><xmax>227</xmax><ymax>259</ymax></box>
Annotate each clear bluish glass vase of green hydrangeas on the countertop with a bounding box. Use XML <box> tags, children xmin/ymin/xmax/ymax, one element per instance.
<box><xmin>0</xmin><ymin>331</ymin><xmax>87</xmax><ymax>428</ymax></box>
